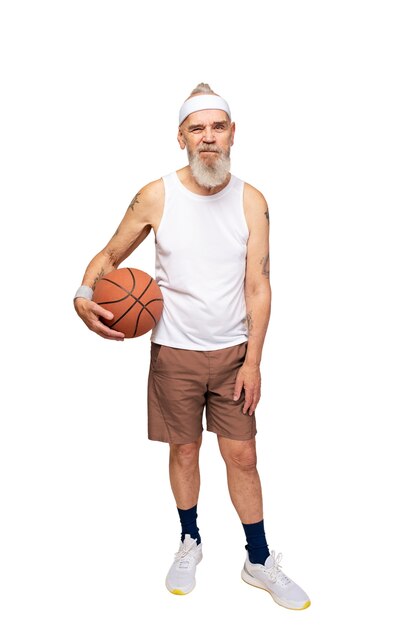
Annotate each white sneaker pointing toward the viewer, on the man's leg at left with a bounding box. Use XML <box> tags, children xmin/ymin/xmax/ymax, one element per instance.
<box><xmin>165</xmin><ymin>535</ymin><xmax>202</xmax><ymax>596</ymax></box>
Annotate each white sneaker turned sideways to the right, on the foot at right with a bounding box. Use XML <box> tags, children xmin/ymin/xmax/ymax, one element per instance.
<box><xmin>241</xmin><ymin>550</ymin><xmax>311</xmax><ymax>610</ymax></box>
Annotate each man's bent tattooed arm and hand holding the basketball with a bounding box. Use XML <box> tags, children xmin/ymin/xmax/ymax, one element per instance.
<box><xmin>74</xmin><ymin>179</ymin><xmax>164</xmax><ymax>340</ymax></box>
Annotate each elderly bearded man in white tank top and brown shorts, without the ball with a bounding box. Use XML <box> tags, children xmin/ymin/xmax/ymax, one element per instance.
<box><xmin>74</xmin><ymin>83</ymin><xmax>310</xmax><ymax>609</ymax></box>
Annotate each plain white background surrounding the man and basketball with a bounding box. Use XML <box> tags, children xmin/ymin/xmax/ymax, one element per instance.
<box><xmin>0</xmin><ymin>0</ymin><xmax>418</xmax><ymax>626</ymax></box>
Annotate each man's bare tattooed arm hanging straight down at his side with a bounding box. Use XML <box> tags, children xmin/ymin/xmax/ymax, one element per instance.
<box><xmin>234</xmin><ymin>184</ymin><xmax>271</xmax><ymax>415</ymax></box>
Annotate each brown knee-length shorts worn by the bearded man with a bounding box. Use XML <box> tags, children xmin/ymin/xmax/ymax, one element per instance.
<box><xmin>148</xmin><ymin>342</ymin><xmax>257</xmax><ymax>443</ymax></box>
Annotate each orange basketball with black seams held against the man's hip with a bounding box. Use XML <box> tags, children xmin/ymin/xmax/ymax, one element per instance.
<box><xmin>93</xmin><ymin>267</ymin><xmax>163</xmax><ymax>339</ymax></box>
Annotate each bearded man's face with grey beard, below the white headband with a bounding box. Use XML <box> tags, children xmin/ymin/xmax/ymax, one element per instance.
<box><xmin>177</xmin><ymin>109</ymin><xmax>235</xmax><ymax>188</ymax></box>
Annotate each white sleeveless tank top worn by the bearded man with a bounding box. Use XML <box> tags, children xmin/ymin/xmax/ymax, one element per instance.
<box><xmin>151</xmin><ymin>172</ymin><xmax>249</xmax><ymax>350</ymax></box>
